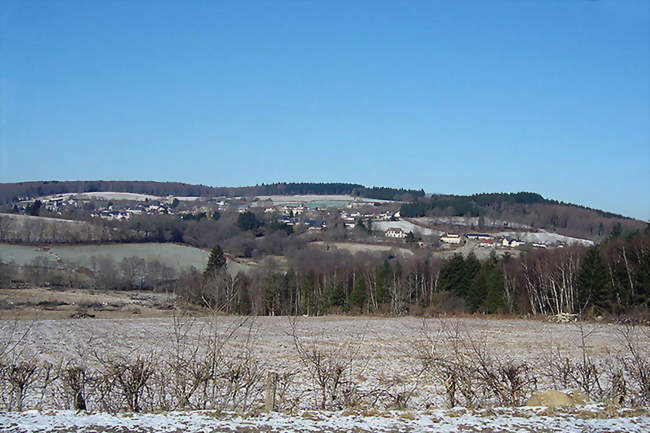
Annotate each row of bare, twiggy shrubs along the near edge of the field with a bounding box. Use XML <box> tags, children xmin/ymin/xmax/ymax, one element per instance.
<box><xmin>0</xmin><ymin>316</ymin><xmax>650</xmax><ymax>412</ymax></box>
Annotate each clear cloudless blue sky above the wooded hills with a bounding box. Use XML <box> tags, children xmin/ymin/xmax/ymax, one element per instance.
<box><xmin>0</xmin><ymin>0</ymin><xmax>650</xmax><ymax>220</ymax></box>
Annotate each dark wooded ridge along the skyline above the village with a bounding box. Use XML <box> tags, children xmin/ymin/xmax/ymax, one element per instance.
<box><xmin>0</xmin><ymin>181</ymin><xmax>646</xmax><ymax>241</ymax></box>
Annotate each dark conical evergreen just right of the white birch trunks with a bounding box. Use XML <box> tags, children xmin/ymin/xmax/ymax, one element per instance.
<box><xmin>576</xmin><ymin>246</ymin><xmax>611</xmax><ymax>313</ymax></box>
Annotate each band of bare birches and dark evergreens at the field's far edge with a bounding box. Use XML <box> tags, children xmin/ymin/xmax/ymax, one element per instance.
<box><xmin>179</xmin><ymin>231</ymin><xmax>650</xmax><ymax>315</ymax></box>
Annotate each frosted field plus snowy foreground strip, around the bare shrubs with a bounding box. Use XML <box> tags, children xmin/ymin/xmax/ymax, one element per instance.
<box><xmin>0</xmin><ymin>316</ymin><xmax>650</xmax><ymax>432</ymax></box>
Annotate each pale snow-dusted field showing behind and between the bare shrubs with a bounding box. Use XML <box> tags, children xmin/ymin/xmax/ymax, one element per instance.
<box><xmin>0</xmin><ymin>316</ymin><xmax>650</xmax><ymax>410</ymax></box>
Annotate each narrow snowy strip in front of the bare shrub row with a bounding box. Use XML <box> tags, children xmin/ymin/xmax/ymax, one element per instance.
<box><xmin>0</xmin><ymin>406</ymin><xmax>650</xmax><ymax>433</ymax></box>
